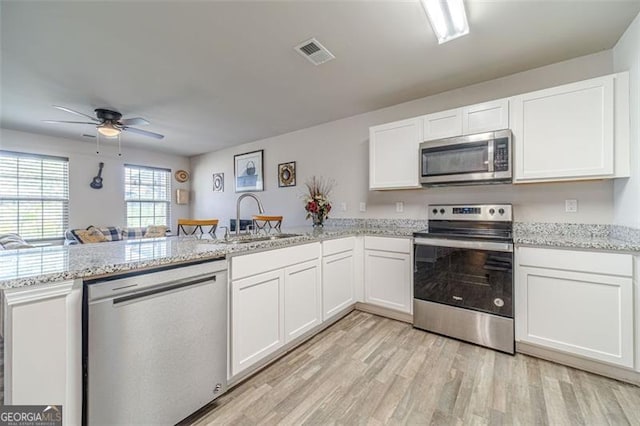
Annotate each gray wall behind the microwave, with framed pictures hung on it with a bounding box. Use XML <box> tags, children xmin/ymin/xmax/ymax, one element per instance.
<box><xmin>191</xmin><ymin>50</ymin><xmax>613</xmax><ymax>225</ymax></box>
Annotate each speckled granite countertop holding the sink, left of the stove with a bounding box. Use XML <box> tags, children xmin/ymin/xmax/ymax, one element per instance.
<box><xmin>0</xmin><ymin>223</ymin><xmax>423</xmax><ymax>290</ymax></box>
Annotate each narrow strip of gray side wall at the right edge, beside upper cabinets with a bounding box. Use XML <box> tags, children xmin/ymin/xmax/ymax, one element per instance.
<box><xmin>613</xmin><ymin>14</ymin><xmax>640</xmax><ymax>228</ymax></box>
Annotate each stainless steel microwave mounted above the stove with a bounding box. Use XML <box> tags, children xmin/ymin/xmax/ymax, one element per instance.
<box><xmin>420</xmin><ymin>129</ymin><xmax>512</xmax><ymax>185</ymax></box>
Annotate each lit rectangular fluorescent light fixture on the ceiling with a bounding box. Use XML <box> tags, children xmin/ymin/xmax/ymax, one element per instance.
<box><xmin>420</xmin><ymin>0</ymin><xmax>469</xmax><ymax>44</ymax></box>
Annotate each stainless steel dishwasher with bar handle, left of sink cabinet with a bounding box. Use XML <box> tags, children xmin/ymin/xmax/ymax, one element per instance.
<box><xmin>83</xmin><ymin>260</ymin><xmax>227</xmax><ymax>425</ymax></box>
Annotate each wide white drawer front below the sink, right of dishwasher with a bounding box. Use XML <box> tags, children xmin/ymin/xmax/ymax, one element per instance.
<box><xmin>231</xmin><ymin>243</ymin><xmax>321</xmax><ymax>280</ymax></box>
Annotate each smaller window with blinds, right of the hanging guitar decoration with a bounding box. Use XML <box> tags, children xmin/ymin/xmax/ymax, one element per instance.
<box><xmin>124</xmin><ymin>164</ymin><xmax>171</xmax><ymax>227</ymax></box>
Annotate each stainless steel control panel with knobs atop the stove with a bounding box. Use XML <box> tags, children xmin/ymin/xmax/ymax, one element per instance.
<box><xmin>427</xmin><ymin>204</ymin><xmax>513</xmax><ymax>222</ymax></box>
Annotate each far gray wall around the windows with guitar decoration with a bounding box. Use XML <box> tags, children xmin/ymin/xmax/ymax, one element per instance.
<box><xmin>0</xmin><ymin>129</ymin><xmax>189</xmax><ymax>231</ymax></box>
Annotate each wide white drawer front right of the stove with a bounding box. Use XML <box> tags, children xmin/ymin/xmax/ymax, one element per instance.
<box><xmin>517</xmin><ymin>247</ymin><xmax>633</xmax><ymax>277</ymax></box>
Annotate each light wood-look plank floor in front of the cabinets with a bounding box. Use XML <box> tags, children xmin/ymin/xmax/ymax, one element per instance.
<box><xmin>190</xmin><ymin>311</ymin><xmax>640</xmax><ymax>425</ymax></box>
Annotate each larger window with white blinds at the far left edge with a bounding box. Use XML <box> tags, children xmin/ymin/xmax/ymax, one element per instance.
<box><xmin>0</xmin><ymin>151</ymin><xmax>69</xmax><ymax>241</ymax></box>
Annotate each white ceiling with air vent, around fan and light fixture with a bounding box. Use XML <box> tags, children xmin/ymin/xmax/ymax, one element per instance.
<box><xmin>0</xmin><ymin>0</ymin><xmax>640</xmax><ymax>155</ymax></box>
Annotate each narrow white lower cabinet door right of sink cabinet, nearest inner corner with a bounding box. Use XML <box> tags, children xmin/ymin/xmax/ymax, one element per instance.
<box><xmin>322</xmin><ymin>250</ymin><xmax>355</xmax><ymax>321</ymax></box>
